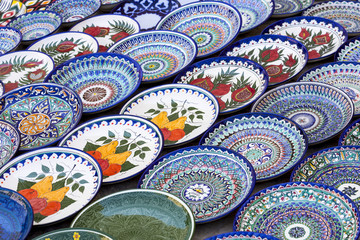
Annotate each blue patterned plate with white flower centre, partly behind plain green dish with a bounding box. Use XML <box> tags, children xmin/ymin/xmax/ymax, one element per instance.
<box><xmin>139</xmin><ymin>146</ymin><xmax>256</xmax><ymax>223</ymax></box>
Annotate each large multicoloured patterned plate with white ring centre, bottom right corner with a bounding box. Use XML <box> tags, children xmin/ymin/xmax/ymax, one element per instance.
<box><xmin>234</xmin><ymin>182</ymin><xmax>360</xmax><ymax>240</ymax></box>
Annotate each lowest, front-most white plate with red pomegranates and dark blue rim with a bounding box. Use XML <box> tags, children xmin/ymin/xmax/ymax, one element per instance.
<box><xmin>174</xmin><ymin>57</ymin><xmax>269</xmax><ymax>113</ymax></box>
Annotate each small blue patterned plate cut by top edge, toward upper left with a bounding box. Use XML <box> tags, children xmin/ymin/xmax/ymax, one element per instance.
<box><xmin>46</xmin><ymin>0</ymin><xmax>101</xmax><ymax>25</ymax></box>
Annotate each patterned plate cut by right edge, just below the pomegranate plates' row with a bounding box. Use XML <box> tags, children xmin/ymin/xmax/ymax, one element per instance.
<box><xmin>298</xmin><ymin>62</ymin><xmax>360</xmax><ymax>115</ymax></box>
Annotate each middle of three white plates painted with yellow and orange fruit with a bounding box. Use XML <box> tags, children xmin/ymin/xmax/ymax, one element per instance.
<box><xmin>59</xmin><ymin>115</ymin><xmax>164</xmax><ymax>183</ymax></box>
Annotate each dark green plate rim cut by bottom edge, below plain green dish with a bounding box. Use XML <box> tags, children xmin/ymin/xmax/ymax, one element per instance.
<box><xmin>32</xmin><ymin>228</ymin><xmax>113</xmax><ymax>240</ymax></box>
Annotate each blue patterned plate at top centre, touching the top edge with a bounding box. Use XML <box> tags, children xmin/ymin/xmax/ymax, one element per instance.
<box><xmin>156</xmin><ymin>1</ymin><xmax>242</xmax><ymax>57</ymax></box>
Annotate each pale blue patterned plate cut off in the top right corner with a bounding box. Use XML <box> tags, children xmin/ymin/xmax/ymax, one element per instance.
<box><xmin>302</xmin><ymin>0</ymin><xmax>360</xmax><ymax>35</ymax></box>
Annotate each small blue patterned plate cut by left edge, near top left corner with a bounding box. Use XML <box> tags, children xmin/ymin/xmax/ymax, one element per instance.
<box><xmin>0</xmin><ymin>27</ymin><xmax>22</xmax><ymax>55</ymax></box>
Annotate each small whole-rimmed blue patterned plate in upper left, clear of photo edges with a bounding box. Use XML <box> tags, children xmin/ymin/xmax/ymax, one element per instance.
<box><xmin>6</xmin><ymin>11</ymin><xmax>62</xmax><ymax>44</ymax></box>
